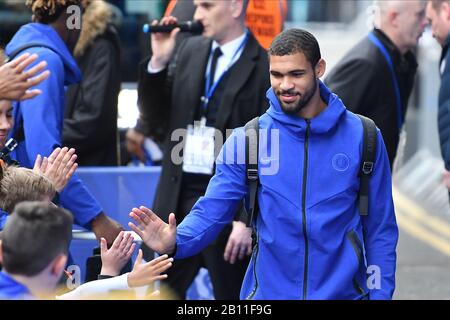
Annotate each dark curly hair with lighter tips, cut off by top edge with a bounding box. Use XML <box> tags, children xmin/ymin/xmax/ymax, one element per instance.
<box><xmin>26</xmin><ymin>0</ymin><xmax>82</xmax><ymax>24</ymax></box>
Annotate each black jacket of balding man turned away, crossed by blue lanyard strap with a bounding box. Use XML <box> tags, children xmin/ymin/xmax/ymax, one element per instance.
<box><xmin>325</xmin><ymin>29</ymin><xmax>417</xmax><ymax>167</ymax></box>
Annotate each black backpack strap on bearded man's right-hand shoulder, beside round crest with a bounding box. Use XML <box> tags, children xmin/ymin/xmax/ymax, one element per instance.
<box><xmin>357</xmin><ymin>114</ymin><xmax>377</xmax><ymax>216</ymax></box>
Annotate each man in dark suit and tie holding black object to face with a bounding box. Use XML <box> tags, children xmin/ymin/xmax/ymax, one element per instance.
<box><xmin>138</xmin><ymin>0</ymin><xmax>270</xmax><ymax>299</ymax></box>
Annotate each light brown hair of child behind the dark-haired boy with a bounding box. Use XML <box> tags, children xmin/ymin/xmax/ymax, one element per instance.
<box><xmin>0</xmin><ymin>166</ymin><xmax>56</xmax><ymax>213</ymax></box>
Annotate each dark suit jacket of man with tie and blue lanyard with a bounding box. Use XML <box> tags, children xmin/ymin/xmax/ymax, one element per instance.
<box><xmin>138</xmin><ymin>35</ymin><xmax>270</xmax><ymax>219</ymax></box>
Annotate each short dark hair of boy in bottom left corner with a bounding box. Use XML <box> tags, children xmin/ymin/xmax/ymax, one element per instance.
<box><xmin>1</xmin><ymin>201</ymin><xmax>73</xmax><ymax>277</ymax></box>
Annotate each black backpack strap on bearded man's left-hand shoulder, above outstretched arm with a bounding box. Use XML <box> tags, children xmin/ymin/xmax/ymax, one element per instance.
<box><xmin>244</xmin><ymin>117</ymin><xmax>259</xmax><ymax>227</ymax></box>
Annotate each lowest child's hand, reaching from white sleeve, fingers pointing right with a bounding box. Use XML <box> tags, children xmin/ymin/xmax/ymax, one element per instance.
<box><xmin>128</xmin><ymin>249</ymin><xmax>173</xmax><ymax>288</ymax></box>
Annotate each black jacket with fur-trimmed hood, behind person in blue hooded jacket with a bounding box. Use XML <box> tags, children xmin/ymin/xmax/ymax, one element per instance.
<box><xmin>63</xmin><ymin>26</ymin><xmax>121</xmax><ymax>166</ymax></box>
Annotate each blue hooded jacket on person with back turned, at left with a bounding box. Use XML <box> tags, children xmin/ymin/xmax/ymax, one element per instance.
<box><xmin>6</xmin><ymin>23</ymin><xmax>102</xmax><ymax>228</ymax></box>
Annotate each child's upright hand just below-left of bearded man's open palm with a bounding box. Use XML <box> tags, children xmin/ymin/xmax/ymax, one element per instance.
<box><xmin>100</xmin><ymin>231</ymin><xmax>136</xmax><ymax>276</ymax></box>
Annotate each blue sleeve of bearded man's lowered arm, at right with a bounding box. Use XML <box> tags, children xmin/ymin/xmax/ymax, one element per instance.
<box><xmin>362</xmin><ymin>130</ymin><xmax>398</xmax><ymax>300</ymax></box>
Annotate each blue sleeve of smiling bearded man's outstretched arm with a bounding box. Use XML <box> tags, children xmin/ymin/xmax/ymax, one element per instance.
<box><xmin>175</xmin><ymin>129</ymin><xmax>247</xmax><ymax>258</ymax></box>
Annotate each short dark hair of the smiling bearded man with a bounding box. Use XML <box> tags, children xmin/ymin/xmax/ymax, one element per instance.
<box><xmin>269</xmin><ymin>29</ymin><xmax>321</xmax><ymax>68</ymax></box>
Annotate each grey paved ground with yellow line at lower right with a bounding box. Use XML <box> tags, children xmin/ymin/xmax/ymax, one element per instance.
<box><xmin>394</xmin><ymin>189</ymin><xmax>450</xmax><ymax>300</ymax></box>
